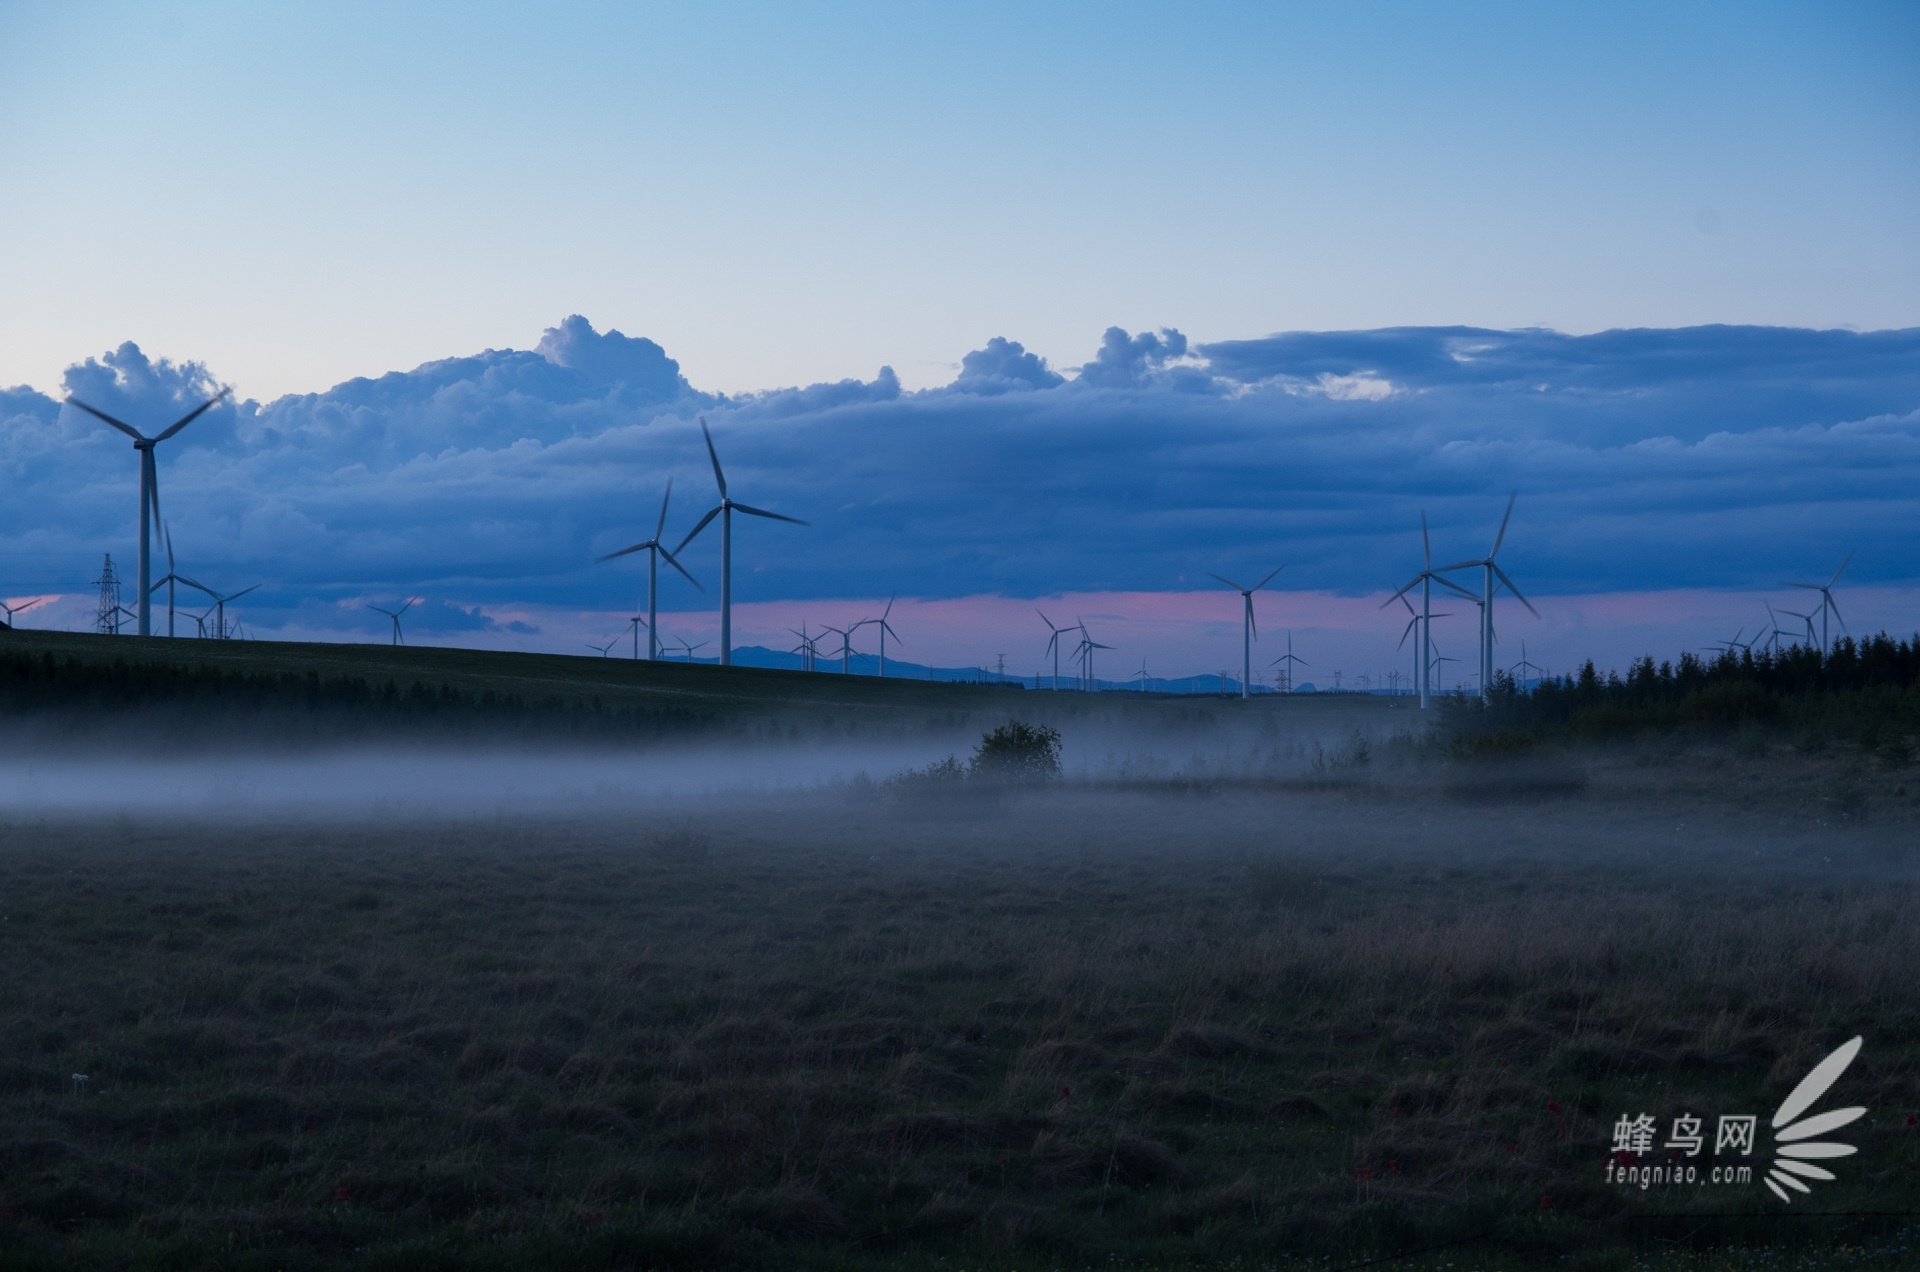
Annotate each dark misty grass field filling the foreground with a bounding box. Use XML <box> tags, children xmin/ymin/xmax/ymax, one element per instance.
<box><xmin>0</xmin><ymin>642</ymin><xmax>1920</xmax><ymax>1270</ymax></box>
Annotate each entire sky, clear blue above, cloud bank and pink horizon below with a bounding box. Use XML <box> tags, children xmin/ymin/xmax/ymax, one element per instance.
<box><xmin>0</xmin><ymin>2</ymin><xmax>1920</xmax><ymax>687</ymax></box>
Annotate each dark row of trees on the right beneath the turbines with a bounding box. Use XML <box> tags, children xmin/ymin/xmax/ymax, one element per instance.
<box><xmin>1453</xmin><ymin>632</ymin><xmax>1920</xmax><ymax>753</ymax></box>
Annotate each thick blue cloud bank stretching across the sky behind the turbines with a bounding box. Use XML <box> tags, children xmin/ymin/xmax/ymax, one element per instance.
<box><xmin>0</xmin><ymin>317</ymin><xmax>1920</xmax><ymax>653</ymax></box>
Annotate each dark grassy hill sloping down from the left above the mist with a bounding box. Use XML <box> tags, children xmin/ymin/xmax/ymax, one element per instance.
<box><xmin>0</xmin><ymin>630</ymin><xmax>1413</xmax><ymax>753</ymax></box>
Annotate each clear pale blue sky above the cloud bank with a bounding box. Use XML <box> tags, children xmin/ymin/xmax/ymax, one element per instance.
<box><xmin>0</xmin><ymin>0</ymin><xmax>1920</xmax><ymax>400</ymax></box>
